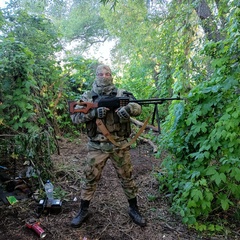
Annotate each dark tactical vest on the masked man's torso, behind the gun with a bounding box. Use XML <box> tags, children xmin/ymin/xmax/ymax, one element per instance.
<box><xmin>86</xmin><ymin>89</ymin><xmax>131</xmax><ymax>139</ymax></box>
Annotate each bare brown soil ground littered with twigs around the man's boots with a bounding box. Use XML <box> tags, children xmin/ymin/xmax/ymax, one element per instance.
<box><xmin>0</xmin><ymin>136</ymin><xmax>240</xmax><ymax>240</ymax></box>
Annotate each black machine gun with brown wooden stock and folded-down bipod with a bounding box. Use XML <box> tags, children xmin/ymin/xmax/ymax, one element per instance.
<box><xmin>68</xmin><ymin>94</ymin><xmax>184</xmax><ymax>133</ymax></box>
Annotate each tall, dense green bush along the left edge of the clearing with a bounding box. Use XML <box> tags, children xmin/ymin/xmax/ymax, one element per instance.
<box><xmin>0</xmin><ymin>9</ymin><xmax>63</xmax><ymax>177</ymax></box>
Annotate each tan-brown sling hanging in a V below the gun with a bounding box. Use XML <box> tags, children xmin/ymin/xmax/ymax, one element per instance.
<box><xmin>96</xmin><ymin>117</ymin><xmax>150</xmax><ymax>149</ymax></box>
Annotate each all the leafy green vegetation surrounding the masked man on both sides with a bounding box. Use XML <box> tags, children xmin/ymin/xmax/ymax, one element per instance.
<box><xmin>0</xmin><ymin>0</ymin><xmax>240</xmax><ymax>232</ymax></box>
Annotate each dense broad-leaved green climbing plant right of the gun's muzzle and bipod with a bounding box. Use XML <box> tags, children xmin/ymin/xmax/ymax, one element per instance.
<box><xmin>156</xmin><ymin>7</ymin><xmax>240</xmax><ymax>231</ymax></box>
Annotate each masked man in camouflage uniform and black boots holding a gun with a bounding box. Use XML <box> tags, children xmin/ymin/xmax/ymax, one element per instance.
<box><xmin>71</xmin><ymin>65</ymin><xmax>146</xmax><ymax>227</ymax></box>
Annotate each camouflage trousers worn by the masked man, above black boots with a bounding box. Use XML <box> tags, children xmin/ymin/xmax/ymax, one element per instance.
<box><xmin>81</xmin><ymin>142</ymin><xmax>138</xmax><ymax>201</ymax></box>
